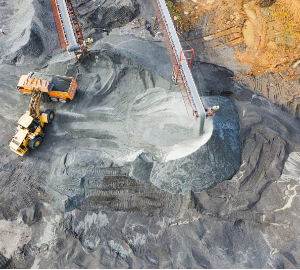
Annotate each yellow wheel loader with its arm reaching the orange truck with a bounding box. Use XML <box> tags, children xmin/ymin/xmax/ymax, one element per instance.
<box><xmin>9</xmin><ymin>85</ymin><xmax>54</xmax><ymax>156</ymax></box>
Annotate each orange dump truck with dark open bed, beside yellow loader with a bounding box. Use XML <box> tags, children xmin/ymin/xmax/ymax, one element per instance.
<box><xmin>17</xmin><ymin>72</ymin><xmax>77</xmax><ymax>103</ymax></box>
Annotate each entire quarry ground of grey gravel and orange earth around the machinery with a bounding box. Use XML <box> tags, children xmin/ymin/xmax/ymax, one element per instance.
<box><xmin>0</xmin><ymin>0</ymin><xmax>300</xmax><ymax>269</ymax></box>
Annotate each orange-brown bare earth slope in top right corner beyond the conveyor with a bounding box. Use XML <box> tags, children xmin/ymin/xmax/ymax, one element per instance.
<box><xmin>169</xmin><ymin>0</ymin><xmax>300</xmax><ymax>117</ymax></box>
